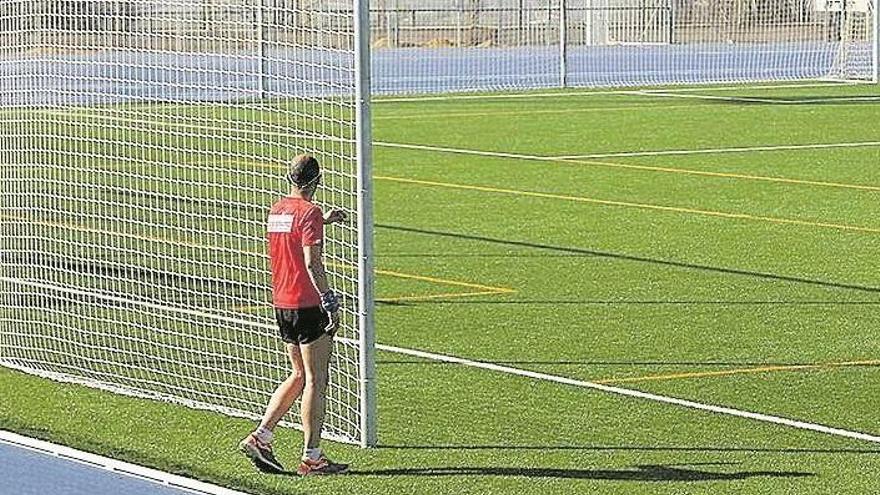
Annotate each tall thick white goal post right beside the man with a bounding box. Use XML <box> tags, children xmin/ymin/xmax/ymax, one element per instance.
<box><xmin>352</xmin><ymin>0</ymin><xmax>377</xmax><ymax>447</ymax></box>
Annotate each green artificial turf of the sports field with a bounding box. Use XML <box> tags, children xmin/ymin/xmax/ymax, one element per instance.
<box><xmin>0</xmin><ymin>80</ymin><xmax>880</xmax><ymax>495</ymax></box>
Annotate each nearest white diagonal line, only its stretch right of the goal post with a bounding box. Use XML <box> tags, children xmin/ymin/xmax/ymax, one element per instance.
<box><xmin>378</xmin><ymin>345</ymin><xmax>880</xmax><ymax>443</ymax></box>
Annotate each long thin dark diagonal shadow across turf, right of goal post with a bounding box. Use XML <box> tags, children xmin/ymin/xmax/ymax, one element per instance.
<box><xmin>376</xmin><ymin>224</ymin><xmax>880</xmax><ymax>294</ymax></box>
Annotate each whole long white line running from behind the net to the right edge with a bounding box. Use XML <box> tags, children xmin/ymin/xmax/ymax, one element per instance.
<box><xmin>6</xmin><ymin>277</ymin><xmax>880</xmax><ymax>450</ymax></box>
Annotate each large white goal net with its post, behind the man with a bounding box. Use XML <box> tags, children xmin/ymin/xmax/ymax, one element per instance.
<box><xmin>0</xmin><ymin>0</ymin><xmax>375</xmax><ymax>445</ymax></box>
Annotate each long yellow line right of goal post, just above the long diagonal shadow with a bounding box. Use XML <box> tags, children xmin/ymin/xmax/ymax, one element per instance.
<box><xmin>373</xmin><ymin>175</ymin><xmax>880</xmax><ymax>234</ymax></box>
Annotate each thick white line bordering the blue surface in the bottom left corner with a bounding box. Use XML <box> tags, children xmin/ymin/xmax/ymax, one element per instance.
<box><xmin>0</xmin><ymin>430</ymin><xmax>246</xmax><ymax>495</ymax></box>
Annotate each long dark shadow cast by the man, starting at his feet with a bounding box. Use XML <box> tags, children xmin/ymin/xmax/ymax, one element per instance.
<box><xmin>351</xmin><ymin>464</ymin><xmax>815</xmax><ymax>481</ymax></box>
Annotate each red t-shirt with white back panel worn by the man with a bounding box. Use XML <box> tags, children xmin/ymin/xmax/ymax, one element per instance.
<box><xmin>268</xmin><ymin>197</ymin><xmax>324</xmax><ymax>309</ymax></box>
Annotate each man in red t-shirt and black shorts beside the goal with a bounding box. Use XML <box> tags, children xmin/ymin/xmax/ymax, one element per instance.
<box><xmin>239</xmin><ymin>155</ymin><xmax>348</xmax><ymax>476</ymax></box>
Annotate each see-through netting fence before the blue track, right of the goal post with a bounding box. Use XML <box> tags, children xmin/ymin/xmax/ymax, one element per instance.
<box><xmin>371</xmin><ymin>0</ymin><xmax>876</xmax><ymax>93</ymax></box>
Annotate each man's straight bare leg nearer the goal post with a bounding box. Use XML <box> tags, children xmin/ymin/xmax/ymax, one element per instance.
<box><xmin>301</xmin><ymin>334</ymin><xmax>333</xmax><ymax>450</ymax></box>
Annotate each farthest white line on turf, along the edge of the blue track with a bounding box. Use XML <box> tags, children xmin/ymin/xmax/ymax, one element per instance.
<box><xmin>371</xmin><ymin>81</ymin><xmax>862</xmax><ymax>103</ymax></box>
